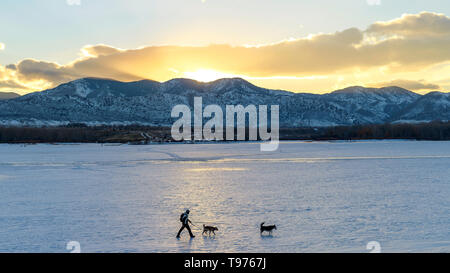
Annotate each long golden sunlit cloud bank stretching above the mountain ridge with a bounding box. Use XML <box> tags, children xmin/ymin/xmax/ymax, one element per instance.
<box><xmin>2</xmin><ymin>12</ymin><xmax>450</xmax><ymax>92</ymax></box>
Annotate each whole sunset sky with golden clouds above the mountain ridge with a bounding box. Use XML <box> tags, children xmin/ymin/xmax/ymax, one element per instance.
<box><xmin>0</xmin><ymin>0</ymin><xmax>450</xmax><ymax>94</ymax></box>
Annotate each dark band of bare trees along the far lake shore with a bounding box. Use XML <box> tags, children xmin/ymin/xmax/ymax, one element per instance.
<box><xmin>0</xmin><ymin>121</ymin><xmax>450</xmax><ymax>144</ymax></box>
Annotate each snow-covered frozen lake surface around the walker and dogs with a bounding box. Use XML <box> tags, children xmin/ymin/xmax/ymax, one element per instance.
<box><xmin>0</xmin><ymin>141</ymin><xmax>450</xmax><ymax>252</ymax></box>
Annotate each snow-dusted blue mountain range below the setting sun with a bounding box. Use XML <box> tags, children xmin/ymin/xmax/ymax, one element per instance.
<box><xmin>0</xmin><ymin>78</ymin><xmax>450</xmax><ymax>127</ymax></box>
